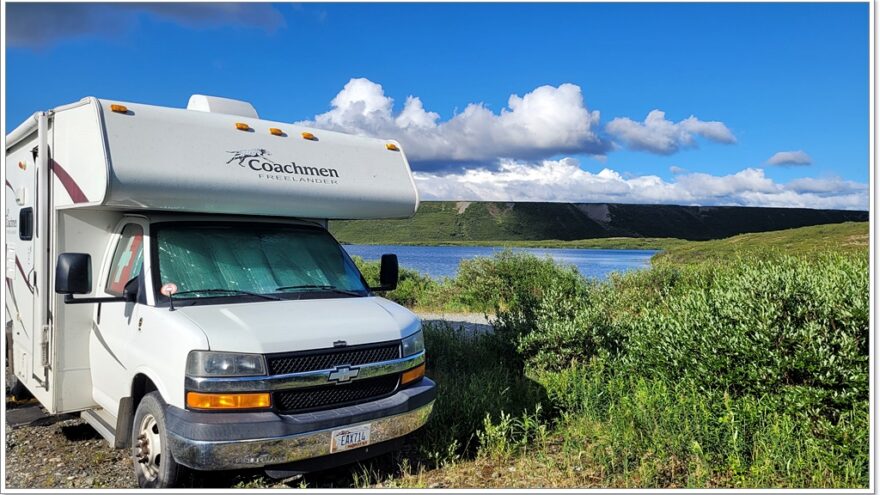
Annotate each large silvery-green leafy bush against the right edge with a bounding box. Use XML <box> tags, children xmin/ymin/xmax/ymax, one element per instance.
<box><xmin>624</xmin><ymin>256</ymin><xmax>869</xmax><ymax>414</ymax></box>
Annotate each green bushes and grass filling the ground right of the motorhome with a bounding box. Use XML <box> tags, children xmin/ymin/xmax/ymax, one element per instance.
<box><xmin>340</xmin><ymin>224</ymin><xmax>870</xmax><ymax>488</ymax></box>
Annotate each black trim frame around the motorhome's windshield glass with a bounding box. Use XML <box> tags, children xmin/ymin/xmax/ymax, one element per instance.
<box><xmin>149</xmin><ymin>220</ymin><xmax>375</xmax><ymax>307</ymax></box>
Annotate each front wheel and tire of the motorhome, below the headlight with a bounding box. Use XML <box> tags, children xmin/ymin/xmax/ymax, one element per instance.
<box><xmin>131</xmin><ymin>392</ymin><xmax>183</xmax><ymax>488</ymax></box>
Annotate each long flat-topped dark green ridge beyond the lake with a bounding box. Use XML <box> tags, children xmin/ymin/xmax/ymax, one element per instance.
<box><xmin>330</xmin><ymin>201</ymin><xmax>868</xmax><ymax>244</ymax></box>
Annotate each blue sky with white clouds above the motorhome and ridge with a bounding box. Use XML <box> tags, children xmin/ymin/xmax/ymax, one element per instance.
<box><xmin>4</xmin><ymin>3</ymin><xmax>869</xmax><ymax>209</ymax></box>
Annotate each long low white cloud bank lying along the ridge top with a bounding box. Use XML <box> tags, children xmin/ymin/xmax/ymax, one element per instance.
<box><xmin>415</xmin><ymin>158</ymin><xmax>868</xmax><ymax>209</ymax></box>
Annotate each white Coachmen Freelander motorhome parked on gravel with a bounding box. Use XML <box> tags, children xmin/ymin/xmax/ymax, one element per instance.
<box><xmin>4</xmin><ymin>95</ymin><xmax>435</xmax><ymax>487</ymax></box>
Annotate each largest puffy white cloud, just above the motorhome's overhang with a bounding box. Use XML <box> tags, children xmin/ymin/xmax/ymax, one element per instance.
<box><xmin>299</xmin><ymin>78</ymin><xmax>609</xmax><ymax>168</ymax></box>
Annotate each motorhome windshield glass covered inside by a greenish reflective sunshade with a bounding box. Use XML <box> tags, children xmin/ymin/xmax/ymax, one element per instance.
<box><xmin>153</xmin><ymin>222</ymin><xmax>368</xmax><ymax>301</ymax></box>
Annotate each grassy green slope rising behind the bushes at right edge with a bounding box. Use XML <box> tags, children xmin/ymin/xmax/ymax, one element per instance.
<box><xmin>653</xmin><ymin>222</ymin><xmax>868</xmax><ymax>263</ymax></box>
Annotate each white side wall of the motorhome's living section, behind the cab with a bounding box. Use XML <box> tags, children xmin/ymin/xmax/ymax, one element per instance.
<box><xmin>5</xmin><ymin>99</ymin><xmax>113</xmax><ymax>413</ymax></box>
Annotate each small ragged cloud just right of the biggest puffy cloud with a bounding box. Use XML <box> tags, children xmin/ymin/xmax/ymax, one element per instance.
<box><xmin>605</xmin><ymin>110</ymin><xmax>736</xmax><ymax>155</ymax></box>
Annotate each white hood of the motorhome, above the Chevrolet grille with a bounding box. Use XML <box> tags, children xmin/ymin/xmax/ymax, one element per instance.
<box><xmin>177</xmin><ymin>297</ymin><xmax>421</xmax><ymax>353</ymax></box>
